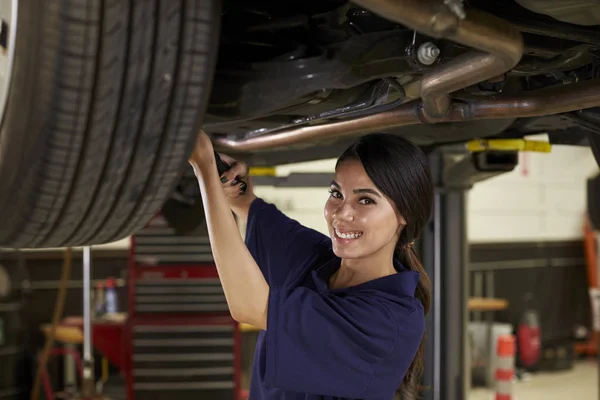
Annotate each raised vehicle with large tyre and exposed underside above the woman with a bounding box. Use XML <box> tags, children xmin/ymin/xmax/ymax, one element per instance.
<box><xmin>0</xmin><ymin>0</ymin><xmax>600</xmax><ymax>247</ymax></box>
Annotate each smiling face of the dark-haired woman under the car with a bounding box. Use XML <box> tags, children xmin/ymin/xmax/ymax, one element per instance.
<box><xmin>324</xmin><ymin>160</ymin><xmax>406</xmax><ymax>259</ymax></box>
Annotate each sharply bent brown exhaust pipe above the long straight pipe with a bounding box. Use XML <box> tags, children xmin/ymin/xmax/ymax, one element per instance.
<box><xmin>353</xmin><ymin>0</ymin><xmax>523</xmax><ymax>117</ymax></box>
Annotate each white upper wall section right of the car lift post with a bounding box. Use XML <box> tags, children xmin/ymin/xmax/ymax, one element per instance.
<box><xmin>468</xmin><ymin>141</ymin><xmax>598</xmax><ymax>242</ymax></box>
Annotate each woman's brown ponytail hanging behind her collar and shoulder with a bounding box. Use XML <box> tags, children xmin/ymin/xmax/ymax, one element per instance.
<box><xmin>397</xmin><ymin>245</ymin><xmax>431</xmax><ymax>400</ymax></box>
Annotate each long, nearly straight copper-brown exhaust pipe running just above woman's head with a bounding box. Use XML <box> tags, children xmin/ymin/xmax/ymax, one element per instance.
<box><xmin>214</xmin><ymin>79</ymin><xmax>600</xmax><ymax>153</ymax></box>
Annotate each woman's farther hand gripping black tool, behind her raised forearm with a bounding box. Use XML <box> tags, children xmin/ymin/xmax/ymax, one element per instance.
<box><xmin>219</xmin><ymin>153</ymin><xmax>256</xmax><ymax>219</ymax></box>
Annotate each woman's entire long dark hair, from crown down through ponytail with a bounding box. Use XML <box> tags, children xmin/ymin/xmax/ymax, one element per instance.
<box><xmin>336</xmin><ymin>133</ymin><xmax>433</xmax><ymax>400</ymax></box>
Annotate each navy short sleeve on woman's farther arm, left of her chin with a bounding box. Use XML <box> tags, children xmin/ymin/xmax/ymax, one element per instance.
<box><xmin>245</xmin><ymin>198</ymin><xmax>333</xmax><ymax>285</ymax></box>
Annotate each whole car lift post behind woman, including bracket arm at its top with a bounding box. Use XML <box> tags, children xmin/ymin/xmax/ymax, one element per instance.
<box><xmin>421</xmin><ymin>146</ymin><xmax>518</xmax><ymax>400</ymax></box>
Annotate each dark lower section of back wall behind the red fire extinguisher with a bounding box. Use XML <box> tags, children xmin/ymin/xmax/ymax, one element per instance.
<box><xmin>469</xmin><ymin>240</ymin><xmax>592</xmax><ymax>343</ymax></box>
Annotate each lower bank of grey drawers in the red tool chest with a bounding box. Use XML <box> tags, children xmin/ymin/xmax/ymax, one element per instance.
<box><xmin>132</xmin><ymin>325</ymin><xmax>235</xmax><ymax>399</ymax></box>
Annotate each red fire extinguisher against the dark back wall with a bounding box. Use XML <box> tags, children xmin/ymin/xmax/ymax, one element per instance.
<box><xmin>516</xmin><ymin>293</ymin><xmax>542</xmax><ymax>371</ymax></box>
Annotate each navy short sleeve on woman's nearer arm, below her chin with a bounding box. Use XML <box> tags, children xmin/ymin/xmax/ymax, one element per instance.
<box><xmin>262</xmin><ymin>287</ymin><xmax>424</xmax><ymax>399</ymax></box>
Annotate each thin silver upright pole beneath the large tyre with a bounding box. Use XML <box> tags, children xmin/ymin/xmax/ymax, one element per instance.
<box><xmin>82</xmin><ymin>246</ymin><xmax>95</xmax><ymax>398</ymax></box>
